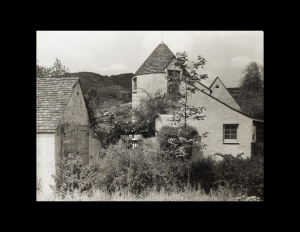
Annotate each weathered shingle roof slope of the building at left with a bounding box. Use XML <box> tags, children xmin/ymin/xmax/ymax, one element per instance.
<box><xmin>36</xmin><ymin>77</ymin><xmax>79</xmax><ymax>133</ymax></box>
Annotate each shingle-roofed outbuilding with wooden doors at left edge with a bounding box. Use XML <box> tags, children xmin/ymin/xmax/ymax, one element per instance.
<box><xmin>36</xmin><ymin>77</ymin><xmax>102</xmax><ymax>192</ymax></box>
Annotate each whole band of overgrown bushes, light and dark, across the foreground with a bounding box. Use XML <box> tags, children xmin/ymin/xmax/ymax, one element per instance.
<box><xmin>50</xmin><ymin>146</ymin><xmax>264</xmax><ymax>199</ymax></box>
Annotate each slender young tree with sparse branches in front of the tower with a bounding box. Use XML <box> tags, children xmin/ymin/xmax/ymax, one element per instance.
<box><xmin>158</xmin><ymin>52</ymin><xmax>208</xmax><ymax>157</ymax></box>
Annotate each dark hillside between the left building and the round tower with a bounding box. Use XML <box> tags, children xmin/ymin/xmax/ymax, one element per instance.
<box><xmin>71</xmin><ymin>72</ymin><xmax>133</xmax><ymax>108</ymax></box>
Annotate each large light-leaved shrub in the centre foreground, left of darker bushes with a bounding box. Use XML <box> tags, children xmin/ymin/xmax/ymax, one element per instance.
<box><xmin>81</xmin><ymin>146</ymin><xmax>186</xmax><ymax>194</ymax></box>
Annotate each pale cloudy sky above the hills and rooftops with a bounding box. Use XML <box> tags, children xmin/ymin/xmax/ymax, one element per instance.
<box><xmin>37</xmin><ymin>31</ymin><xmax>263</xmax><ymax>87</ymax></box>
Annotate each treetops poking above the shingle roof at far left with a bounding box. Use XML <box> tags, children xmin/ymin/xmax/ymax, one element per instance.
<box><xmin>36</xmin><ymin>58</ymin><xmax>70</xmax><ymax>78</ymax></box>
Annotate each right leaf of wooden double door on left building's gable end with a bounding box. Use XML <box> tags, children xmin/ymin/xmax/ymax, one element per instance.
<box><xmin>77</xmin><ymin>126</ymin><xmax>89</xmax><ymax>164</ymax></box>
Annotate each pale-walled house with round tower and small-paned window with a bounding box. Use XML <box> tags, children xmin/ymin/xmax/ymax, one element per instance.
<box><xmin>132</xmin><ymin>42</ymin><xmax>263</xmax><ymax>159</ymax></box>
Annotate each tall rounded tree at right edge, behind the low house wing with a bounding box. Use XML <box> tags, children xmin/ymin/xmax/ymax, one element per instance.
<box><xmin>238</xmin><ymin>62</ymin><xmax>264</xmax><ymax>118</ymax></box>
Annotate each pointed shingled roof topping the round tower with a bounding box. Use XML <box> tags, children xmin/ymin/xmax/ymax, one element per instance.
<box><xmin>135</xmin><ymin>42</ymin><xmax>175</xmax><ymax>75</ymax></box>
